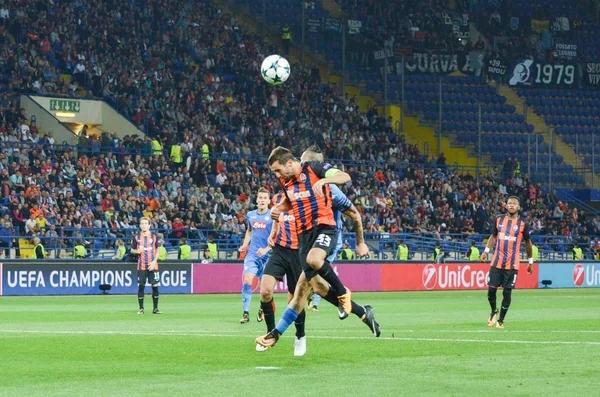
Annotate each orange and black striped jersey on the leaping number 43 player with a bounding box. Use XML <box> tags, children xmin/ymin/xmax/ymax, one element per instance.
<box><xmin>279</xmin><ymin>161</ymin><xmax>336</xmax><ymax>234</ymax></box>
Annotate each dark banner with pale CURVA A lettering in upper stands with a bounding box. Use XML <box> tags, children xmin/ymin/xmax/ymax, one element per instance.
<box><xmin>405</xmin><ymin>53</ymin><xmax>484</xmax><ymax>74</ymax></box>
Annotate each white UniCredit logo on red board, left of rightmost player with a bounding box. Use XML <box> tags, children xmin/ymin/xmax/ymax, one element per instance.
<box><xmin>422</xmin><ymin>264</ymin><xmax>488</xmax><ymax>290</ymax></box>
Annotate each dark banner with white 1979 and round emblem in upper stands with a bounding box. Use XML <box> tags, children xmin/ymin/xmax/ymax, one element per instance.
<box><xmin>508</xmin><ymin>59</ymin><xmax>579</xmax><ymax>88</ymax></box>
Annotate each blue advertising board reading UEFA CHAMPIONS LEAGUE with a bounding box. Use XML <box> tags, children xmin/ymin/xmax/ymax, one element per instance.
<box><xmin>0</xmin><ymin>261</ymin><xmax>192</xmax><ymax>295</ymax></box>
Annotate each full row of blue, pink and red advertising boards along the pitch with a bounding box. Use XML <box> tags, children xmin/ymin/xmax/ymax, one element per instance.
<box><xmin>0</xmin><ymin>260</ymin><xmax>600</xmax><ymax>296</ymax></box>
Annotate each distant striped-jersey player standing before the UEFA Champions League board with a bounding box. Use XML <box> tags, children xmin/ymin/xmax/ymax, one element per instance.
<box><xmin>131</xmin><ymin>217</ymin><xmax>162</xmax><ymax>314</ymax></box>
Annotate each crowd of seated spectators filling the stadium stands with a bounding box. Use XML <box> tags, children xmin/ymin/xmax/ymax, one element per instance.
<box><xmin>0</xmin><ymin>0</ymin><xmax>600</xmax><ymax>258</ymax></box>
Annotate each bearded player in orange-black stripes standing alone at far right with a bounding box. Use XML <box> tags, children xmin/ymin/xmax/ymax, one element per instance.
<box><xmin>481</xmin><ymin>196</ymin><xmax>533</xmax><ymax>328</ymax></box>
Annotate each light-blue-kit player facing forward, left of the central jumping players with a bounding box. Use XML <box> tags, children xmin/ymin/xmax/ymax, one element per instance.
<box><xmin>239</xmin><ymin>188</ymin><xmax>273</xmax><ymax>324</ymax></box>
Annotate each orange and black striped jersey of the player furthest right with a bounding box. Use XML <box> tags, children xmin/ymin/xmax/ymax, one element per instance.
<box><xmin>492</xmin><ymin>215</ymin><xmax>531</xmax><ymax>270</ymax></box>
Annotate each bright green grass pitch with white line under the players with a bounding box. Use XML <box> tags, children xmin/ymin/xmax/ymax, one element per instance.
<box><xmin>0</xmin><ymin>289</ymin><xmax>600</xmax><ymax>397</ymax></box>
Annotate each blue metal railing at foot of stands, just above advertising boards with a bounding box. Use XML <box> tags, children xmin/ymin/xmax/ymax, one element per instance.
<box><xmin>0</xmin><ymin>228</ymin><xmax>594</xmax><ymax>261</ymax></box>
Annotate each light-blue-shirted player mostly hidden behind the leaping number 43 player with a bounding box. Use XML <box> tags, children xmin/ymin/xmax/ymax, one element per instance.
<box><xmin>301</xmin><ymin>145</ymin><xmax>381</xmax><ymax>337</ymax></box>
